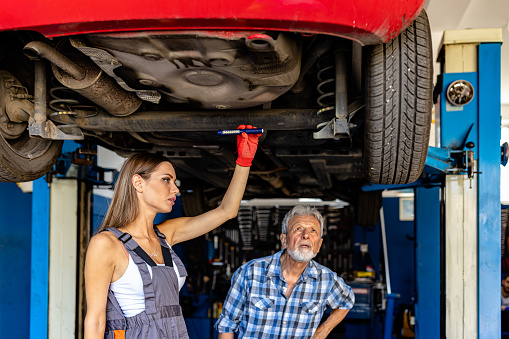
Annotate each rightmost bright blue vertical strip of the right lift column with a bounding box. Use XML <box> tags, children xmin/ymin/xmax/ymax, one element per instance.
<box><xmin>478</xmin><ymin>43</ymin><xmax>501</xmax><ymax>339</ymax></box>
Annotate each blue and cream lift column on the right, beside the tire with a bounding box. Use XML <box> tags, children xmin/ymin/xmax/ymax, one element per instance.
<box><xmin>365</xmin><ymin>29</ymin><xmax>508</xmax><ymax>338</ymax></box>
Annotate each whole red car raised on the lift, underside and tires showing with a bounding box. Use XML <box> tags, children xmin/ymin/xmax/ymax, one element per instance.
<box><xmin>0</xmin><ymin>0</ymin><xmax>433</xmax><ymax>224</ymax></box>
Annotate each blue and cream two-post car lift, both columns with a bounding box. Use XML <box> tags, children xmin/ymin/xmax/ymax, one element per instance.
<box><xmin>25</xmin><ymin>29</ymin><xmax>507</xmax><ymax>339</ymax></box>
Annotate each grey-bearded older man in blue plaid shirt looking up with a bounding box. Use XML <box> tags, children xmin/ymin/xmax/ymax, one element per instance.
<box><xmin>215</xmin><ymin>206</ymin><xmax>354</xmax><ymax>339</ymax></box>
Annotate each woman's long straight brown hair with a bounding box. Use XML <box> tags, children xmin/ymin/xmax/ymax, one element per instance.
<box><xmin>99</xmin><ymin>153</ymin><xmax>170</xmax><ymax>232</ymax></box>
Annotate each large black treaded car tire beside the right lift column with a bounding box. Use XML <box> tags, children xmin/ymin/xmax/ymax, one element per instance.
<box><xmin>363</xmin><ymin>10</ymin><xmax>433</xmax><ymax>185</ymax></box>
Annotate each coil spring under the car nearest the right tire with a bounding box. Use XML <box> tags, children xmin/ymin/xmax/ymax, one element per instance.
<box><xmin>316</xmin><ymin>55</ymin><xmax>336</xmax><ymax>129</ymax></box>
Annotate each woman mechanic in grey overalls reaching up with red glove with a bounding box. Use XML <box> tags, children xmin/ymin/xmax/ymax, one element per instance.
<box><xmin>85</xmin><ymin>125</ymin><xmax>260</xmax><ymax>339</ymax></box>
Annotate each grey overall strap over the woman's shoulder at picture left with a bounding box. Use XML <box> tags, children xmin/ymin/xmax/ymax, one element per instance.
<box><xmin>107</xmin><ymin>227</ymin><xmax>157</xmax><ymax>314</ymax></box>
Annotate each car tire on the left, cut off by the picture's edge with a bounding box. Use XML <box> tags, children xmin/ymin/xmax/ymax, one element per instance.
<box><xmin>0</xmin><ymin>35</ymin><xmax>62</xmax><ymax>182</ymax></box>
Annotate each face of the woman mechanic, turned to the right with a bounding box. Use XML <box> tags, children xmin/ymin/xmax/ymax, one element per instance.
<box><xmin>135</xmin><ymin>161</ymin><xmax>179</xmax><ymax>213</ymax></box>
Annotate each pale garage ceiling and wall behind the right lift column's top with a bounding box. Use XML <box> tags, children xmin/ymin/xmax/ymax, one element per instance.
<box><xmin>424</xmin><ymin>0</ymin><xmax>509</xmax><ymax>126</ymax></box>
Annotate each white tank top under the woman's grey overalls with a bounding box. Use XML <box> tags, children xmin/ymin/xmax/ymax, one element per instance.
<box><xmin>110</xmin><ymin>254</ymin><xmax>186</xmax><ymax>317</ymax></box>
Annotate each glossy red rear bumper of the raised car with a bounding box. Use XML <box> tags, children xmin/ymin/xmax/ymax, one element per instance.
<box><xmin>0</xmin><ymin>0</ymin><xmax>425</xmax><ymax>45</ymax></box>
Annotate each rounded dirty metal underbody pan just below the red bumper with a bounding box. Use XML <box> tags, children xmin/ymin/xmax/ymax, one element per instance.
<box><xmin>76</xmin><ymin>31</ymin><xmax>302</xmax><ymax>109</ymax></box>
